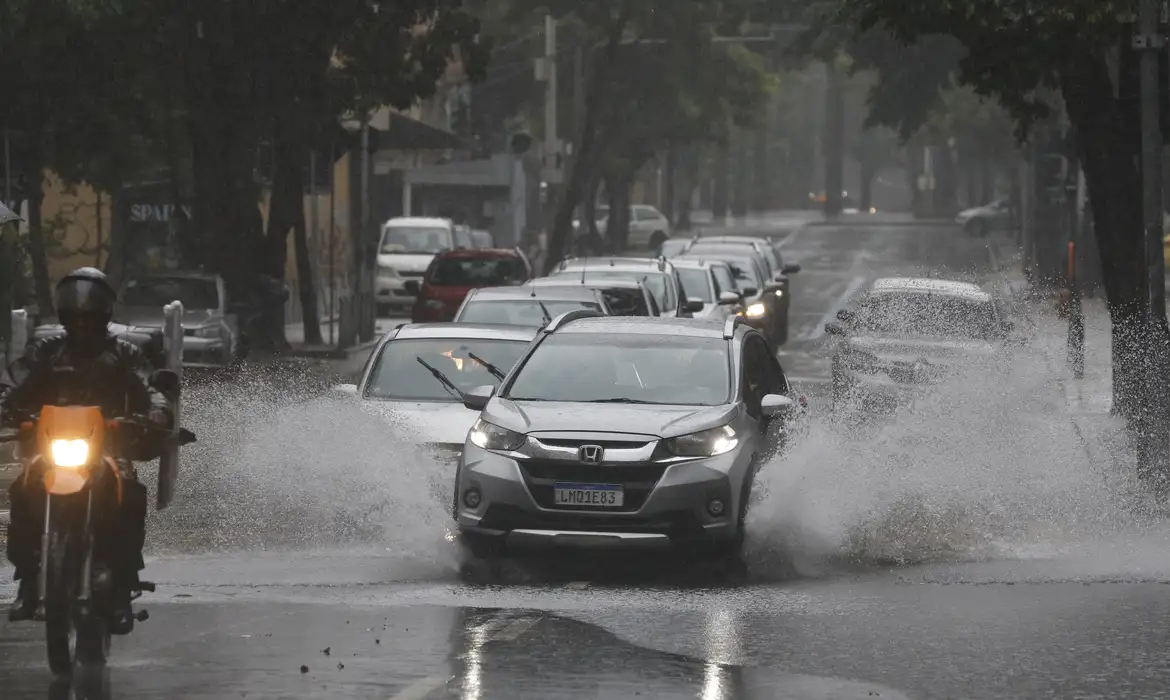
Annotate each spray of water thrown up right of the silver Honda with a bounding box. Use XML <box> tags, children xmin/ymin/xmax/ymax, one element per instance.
<box><xmin>748</xmin><ymin>304</ymin><xmax>1156</xmax><ymax>575</ymax></box>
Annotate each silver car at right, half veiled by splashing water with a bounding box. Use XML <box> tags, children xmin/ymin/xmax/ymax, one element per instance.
<box><xmin>825</xmin><ymin>277</ymin><xmax>1016</xmax><ymax>406</ymax></box>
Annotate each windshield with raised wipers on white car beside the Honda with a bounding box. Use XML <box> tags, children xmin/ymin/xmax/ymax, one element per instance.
<box><xmin>365</xmin><ymin>338</ymin><xmax>528</xmax><ymax>402</ymax></box>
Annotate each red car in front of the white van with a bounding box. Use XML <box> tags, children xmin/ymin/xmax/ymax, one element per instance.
<box><xmin>411</xmin><ymin>248</ymin><xmax>532</xmax><ymax>323</ymax></box>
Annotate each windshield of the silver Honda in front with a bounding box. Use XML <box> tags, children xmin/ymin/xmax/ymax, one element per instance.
<box><xmin>507</xmin><ymin>334</ymin><xmax>731</xmax><ymax>406</ymax></box>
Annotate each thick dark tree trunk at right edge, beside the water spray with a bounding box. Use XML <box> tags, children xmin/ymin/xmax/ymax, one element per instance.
<box><xmin>1061</xmin><ymin>55</ymin><xmax>1152</xmax><ymax>421</ymax></box>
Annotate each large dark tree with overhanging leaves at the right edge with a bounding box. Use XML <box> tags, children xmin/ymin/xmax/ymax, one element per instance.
<box><xmin>832</xmin><ymin>0</ymin><xmax>1165</xmax><ymax>444</ymax></box>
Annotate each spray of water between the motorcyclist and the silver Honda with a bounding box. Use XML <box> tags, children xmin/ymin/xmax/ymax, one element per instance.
<box><xmin>143</xmin><ymin>365</ymin><xmax>454</xmax><ymax>585</ymax></box>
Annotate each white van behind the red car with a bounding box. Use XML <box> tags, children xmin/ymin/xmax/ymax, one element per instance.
<box><xmin>374</xmin><ymin>217</ymin><xmax>455</xmax><ymax>313</ymax></box>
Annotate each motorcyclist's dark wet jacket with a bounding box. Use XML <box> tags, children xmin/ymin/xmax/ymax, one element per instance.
<box><xmin>0</xmin><ymin>336</ymin><xmax>170</xmax><ymax>420</ymax></box>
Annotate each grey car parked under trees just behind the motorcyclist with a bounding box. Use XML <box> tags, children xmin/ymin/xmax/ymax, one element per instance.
<box><xmin>113</xmin><ymin>272</ymin><xmax>247</xmax><ymax>369</ymax></box>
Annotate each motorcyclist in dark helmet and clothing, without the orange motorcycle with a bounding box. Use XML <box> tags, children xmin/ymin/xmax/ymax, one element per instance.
<box><xmin>0</xmin><ymin>268</ymin><xmax>172</xmax><ymax>634</ymax></box>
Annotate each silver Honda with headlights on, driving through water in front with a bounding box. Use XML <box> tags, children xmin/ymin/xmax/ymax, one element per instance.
<box><xmin>452</xmin><ymin>311</ymin><xmax>804</xmax><ymax>571</ymax></box>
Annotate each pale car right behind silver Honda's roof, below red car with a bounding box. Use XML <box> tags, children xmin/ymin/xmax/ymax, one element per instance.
<box><xmin>454</xmin><ymin>284</ymin><xmax>610</xmax><ymax>328</ymax></box>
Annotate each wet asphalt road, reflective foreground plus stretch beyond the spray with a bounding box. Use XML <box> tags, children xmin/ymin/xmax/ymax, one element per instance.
<box><xmin>0</xmin><ymin>225</ymin><xmax>1170</xmax><ymax>700</ymax></box>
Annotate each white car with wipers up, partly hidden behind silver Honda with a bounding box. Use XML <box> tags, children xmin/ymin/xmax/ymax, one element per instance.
<box><xmin>333</xmin><ymin>323</ymin><xmax>536</xmax><ymax>460</ymax></box>
